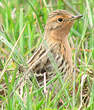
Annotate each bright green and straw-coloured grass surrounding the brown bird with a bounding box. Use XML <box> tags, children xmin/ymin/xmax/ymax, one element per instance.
<box><xmin>0</xmin><ymin>0</ymin><xmax>94</xmax><ymax>110</ymax></box>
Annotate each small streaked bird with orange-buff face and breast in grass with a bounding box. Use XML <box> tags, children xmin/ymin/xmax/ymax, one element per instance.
<box><xmin>27</xmin><ymin>10</ymin><xmax>82</xmax><ymax>86</ymax></box>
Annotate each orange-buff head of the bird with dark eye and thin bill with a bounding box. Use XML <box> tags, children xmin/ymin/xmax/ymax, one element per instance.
<box><xmin>45</xmin><ymin>10</ymin><xmax>82</xmax><ymax>40</ymax></box>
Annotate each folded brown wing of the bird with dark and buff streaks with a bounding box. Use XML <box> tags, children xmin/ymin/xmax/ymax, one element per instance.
<box><xmin>27</xmin><ymin>43</ymin><xmax>56</xmax><ymax>72</ymax></box>
